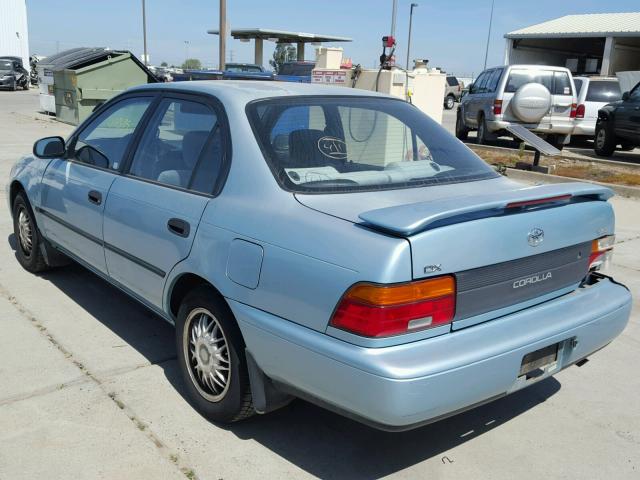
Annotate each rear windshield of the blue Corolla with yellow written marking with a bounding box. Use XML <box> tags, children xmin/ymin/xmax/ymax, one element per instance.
<box><xmin>247</xmin><ymin>96</ymin><xmax>497</xmax><ymax>193</ymax></box>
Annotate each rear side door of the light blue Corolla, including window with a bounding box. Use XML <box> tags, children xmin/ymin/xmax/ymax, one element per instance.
<box><xmin>104</xmin><ymin>95</ymin><xmax>228</xmax><ymax>308</ymax></box>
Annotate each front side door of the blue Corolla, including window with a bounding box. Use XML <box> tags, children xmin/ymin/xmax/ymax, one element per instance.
<box><xmin>38</xmin><ymin>97</ymin><xmax>152</xmax><ymax>273</ymax></box>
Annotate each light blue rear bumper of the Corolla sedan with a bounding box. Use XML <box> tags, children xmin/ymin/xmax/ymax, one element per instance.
<box><xmin>229</xmin><ymin>279</ymin><xmax>631</xmax><ymax>430</ymax></box>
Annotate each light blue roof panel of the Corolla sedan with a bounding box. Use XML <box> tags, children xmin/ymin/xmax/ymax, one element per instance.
<box><xmin>128</xmin><ymin>80</ymin><xmax>397</xmax><ymax>105</ymax></box>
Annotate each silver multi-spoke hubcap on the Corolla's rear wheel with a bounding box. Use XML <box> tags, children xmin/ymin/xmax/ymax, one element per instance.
<box><xmin>183</xmin><ymin>308</ymin><xmax>231</xmax><ymax>402</ymax></box>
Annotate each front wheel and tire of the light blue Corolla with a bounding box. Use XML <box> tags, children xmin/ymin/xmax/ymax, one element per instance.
<box><xmin>12</xmin><ymin>192</ymin><xmax>49</xmax><ymax>273</ymax></box>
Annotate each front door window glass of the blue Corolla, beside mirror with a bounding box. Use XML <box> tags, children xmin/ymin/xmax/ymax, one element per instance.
<box><xmin>72</xmin><ymin>97</ymin><xmax>153</xmax><ymax>170</ymax></box>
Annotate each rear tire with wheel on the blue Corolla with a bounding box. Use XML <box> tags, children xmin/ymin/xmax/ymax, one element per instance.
<box><xmin>176</xmin><ymin>287</ymin><xmax>255</xmax><ymax>423</ymax></box>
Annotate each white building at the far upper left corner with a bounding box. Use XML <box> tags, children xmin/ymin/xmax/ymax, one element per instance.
<box><xmin>0</xmin><ymin>0</ymin><xmax>29</xmax><ymax>70</ymax></box>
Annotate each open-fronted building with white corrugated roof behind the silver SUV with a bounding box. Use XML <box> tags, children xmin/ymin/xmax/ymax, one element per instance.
<box><xmin>505</xmin><ymin>12</ymin><xmax>640</xmax><ymax>75</ymax></box>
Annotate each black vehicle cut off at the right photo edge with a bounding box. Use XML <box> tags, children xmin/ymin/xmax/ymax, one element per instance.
<box><xmin>594</xmin><ymin>83</ymin><xmax>640</xmax><ymax>157</ymax></box>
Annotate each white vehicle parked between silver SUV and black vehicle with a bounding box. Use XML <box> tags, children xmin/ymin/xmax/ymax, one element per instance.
<box><xmin>572</xmin><ymin>77</ymin><xmax>622</xmax><ymax>138</ymax></box>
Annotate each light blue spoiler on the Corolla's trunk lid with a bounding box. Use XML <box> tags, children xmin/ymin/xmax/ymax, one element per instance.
<box><xmin>359</xmin><ymin>182</ymin><xmax>614</xmax><ymax>236</ymax></box>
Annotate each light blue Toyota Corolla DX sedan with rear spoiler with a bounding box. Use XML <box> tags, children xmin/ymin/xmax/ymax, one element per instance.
<box><xmin>7</xmin><ymin>81</ymin><xmax>631</xmax><ymax>430</ymax></box>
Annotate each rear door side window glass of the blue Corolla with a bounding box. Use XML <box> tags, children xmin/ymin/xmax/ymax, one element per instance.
<box><xmin>129</xmin><ymin>99</ymin><xmax>223</xmax><ymax>194</ymax></box>
